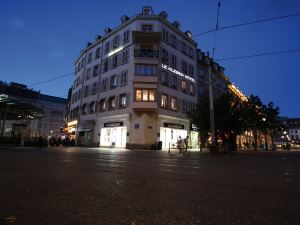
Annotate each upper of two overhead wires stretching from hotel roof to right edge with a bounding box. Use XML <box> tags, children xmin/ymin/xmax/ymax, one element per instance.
<box><xmin>193</xmin><ymin>12</ymin><xmax>300</xmax><ymax>37</ymax></box>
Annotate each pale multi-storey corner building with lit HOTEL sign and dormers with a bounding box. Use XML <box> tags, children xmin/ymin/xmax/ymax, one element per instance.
<box><xmin>68</xmin><ymin>6</ymin><xmax>198</xmax><ymax>149</ymax></box>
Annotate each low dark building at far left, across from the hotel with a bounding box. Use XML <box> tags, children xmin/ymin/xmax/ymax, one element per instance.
<box><xmin>0</xmin><ymin>81</ymin><xmax>66</xmax><ymax>141</ymax></box>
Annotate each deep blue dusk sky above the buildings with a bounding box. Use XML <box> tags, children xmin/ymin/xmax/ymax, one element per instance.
<box><xmin>0</xmin><ymin>0</ymin><xmax>300</xmax><ymax>117</ymax></box>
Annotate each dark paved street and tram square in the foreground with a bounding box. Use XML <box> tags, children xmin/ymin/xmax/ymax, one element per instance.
<box><xmin>0</xmin><ymin>147</ymin><xmax>300</xmax><ymax>225</ymax></box>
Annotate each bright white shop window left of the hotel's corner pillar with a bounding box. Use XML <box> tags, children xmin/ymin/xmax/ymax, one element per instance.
<box><xmin>100</xmin><ymin>122</ymin><xmax>127</xmax><ymax>148</ymax></box>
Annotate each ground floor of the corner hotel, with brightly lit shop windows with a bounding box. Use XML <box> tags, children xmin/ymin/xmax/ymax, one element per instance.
<box><xmin>77</xmin><ymin>113</ymin><xmax>199</xmax><ymax>150</ymax></box>
